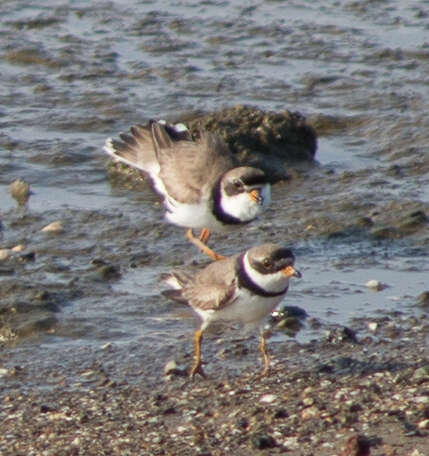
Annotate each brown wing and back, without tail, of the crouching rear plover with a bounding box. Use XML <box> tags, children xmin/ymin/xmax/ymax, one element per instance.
<box><xmin>152</xmin><ymin>123</ymin><xmax>233</xmax><ymax>203</ymax></box>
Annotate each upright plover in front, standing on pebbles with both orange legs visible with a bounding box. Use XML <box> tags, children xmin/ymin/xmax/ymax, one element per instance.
<box><xmin>163</xmin><ymin>244</ymin><xmax>301</xmax><ymax>378</ymax></box>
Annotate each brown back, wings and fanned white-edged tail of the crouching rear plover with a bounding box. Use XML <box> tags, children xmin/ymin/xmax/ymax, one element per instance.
<box><xmin>104</xmin><ymin>121</ymin><xmax>234</xmax><ymax>204</ymax></box>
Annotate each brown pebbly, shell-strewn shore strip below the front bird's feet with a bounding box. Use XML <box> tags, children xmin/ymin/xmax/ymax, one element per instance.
<box><xmin>0</xmin><ymin>314</ymin><xmax>429</xmax><ymax>456</ymax></box>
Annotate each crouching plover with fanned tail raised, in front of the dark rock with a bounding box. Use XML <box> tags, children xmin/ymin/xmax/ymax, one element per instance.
<box><xmin>104</xmin><ymin>121</ymin><xmax>271</xmax><ymax>259</ymax></box>
